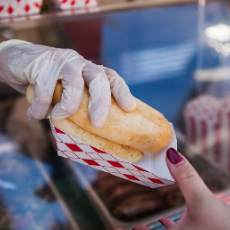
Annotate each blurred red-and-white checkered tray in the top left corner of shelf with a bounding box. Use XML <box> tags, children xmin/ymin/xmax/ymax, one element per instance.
<box><xmin>0</xmin><ymin>0</ymin><xmax>43</xmax><ymax>19</ymax></box>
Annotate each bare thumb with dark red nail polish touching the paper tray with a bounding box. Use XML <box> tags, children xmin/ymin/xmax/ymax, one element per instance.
<box><xmin>166</xmin><ymin>148</ymin><xmax>212</xmax><ymax>205</ymax></box>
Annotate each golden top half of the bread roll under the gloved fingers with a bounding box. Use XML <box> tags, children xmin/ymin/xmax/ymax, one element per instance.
<box><xmin>27</xmin><ymin>81</ymin><xmax>171</xmax><ymax>156</ymax></box>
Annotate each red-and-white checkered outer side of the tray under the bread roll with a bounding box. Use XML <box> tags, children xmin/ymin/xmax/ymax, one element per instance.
<box><xmin>51</xmin><ymin>124</ymin><xmax>174</xmax><ymax>188</ymax></box>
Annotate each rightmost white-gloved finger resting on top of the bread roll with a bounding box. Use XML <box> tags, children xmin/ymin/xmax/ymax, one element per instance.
<box><xmin>104</xmin><ymin>68</ymin><xmax>136</xmax><ymax>111</ymax></box>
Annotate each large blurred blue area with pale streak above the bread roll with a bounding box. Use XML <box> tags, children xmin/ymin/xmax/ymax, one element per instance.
<box><xmin>102</xmin><ymin>5</ymin><xmax>198</xmax><ymax>123</ymax></box>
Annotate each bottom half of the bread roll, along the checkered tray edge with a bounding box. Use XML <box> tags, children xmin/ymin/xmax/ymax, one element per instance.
<box><xmin>51</xmin><ymin>119</ymin><xmax>143</xmax><ymax>163</ymax></box>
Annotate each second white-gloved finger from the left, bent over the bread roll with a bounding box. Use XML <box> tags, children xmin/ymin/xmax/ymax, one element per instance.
<box><xmin>51</xmin><ymin>67</ymin><xmax>84</xmax><ymax>120</ymax></box>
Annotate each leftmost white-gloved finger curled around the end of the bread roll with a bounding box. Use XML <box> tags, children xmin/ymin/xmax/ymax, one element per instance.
<box><xmin>27</xmin><ymin>83</ymin><xmax>54</xmax><ymax>120</ymax></box>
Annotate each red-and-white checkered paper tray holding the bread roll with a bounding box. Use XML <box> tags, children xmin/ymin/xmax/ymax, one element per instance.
<box><xmin>51</xmin><ymin>124</ymin><xmax>177</xmax><ymax>188</ymax></box>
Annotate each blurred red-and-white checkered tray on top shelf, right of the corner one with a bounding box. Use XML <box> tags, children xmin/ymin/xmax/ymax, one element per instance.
<box><xmin>50</xmin><ymin>0</ymin><xmax>98</xmax><ymax>10</ymax></box>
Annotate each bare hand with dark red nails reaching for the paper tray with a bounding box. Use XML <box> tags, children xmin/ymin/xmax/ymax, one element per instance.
<box><xmin>117</xmin><ymin>148</ymin><xmax>230</xmax><ymax>230</ymax></box>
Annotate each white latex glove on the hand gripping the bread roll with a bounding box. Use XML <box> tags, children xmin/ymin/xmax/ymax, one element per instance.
<box><xmin>0</xmin><ymin>40</ymin><xmax>136</xmax><ymax>127</ymax></box>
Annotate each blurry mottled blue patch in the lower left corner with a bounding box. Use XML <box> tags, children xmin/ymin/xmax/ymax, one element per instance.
<box><xmin>0</xmin><ymin>139</ymin><xmax>67</xmax><ymax>230</ymax></box>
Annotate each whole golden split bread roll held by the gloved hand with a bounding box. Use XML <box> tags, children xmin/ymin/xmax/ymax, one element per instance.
<box><xmin>26</xmin><ymin>81</ymin><xmax>171</xmax><ymax>163</ymax></box>
